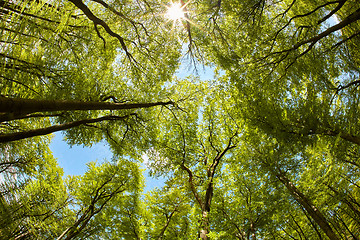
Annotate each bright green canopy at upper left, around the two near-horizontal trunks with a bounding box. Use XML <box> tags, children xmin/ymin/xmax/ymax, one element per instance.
<box><xmin>0</xmin><ymin>1</ymin><xmax>181</xmax><ymax>153</ymax></box>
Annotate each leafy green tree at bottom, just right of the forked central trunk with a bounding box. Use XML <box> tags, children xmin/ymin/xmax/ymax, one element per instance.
<box><xmin>213</xmin><ymin>165</ymin><xmax>280</xmax><ymax>240</ymax></box>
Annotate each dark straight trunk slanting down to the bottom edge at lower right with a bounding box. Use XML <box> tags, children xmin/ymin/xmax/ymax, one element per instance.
<box><xmin>276</xmin><ymin>174</ymin><xmax>339</xmax><ymax>240</ymax></box>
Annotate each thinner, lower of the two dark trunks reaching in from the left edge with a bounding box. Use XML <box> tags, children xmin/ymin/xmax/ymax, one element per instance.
<box><xmin>0</xmin><ymin>115</ymin><xmax>130</xmax><ymax>143</ymax></box>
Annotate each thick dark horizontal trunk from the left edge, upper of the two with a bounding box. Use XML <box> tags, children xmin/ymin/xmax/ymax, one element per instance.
<box><xmin>0</xmin><ymin>97</ymin><xmax>174</xmax><ymax>122</ymax></box>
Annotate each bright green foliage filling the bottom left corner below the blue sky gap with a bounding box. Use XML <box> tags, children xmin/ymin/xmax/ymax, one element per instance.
<box><xmin>1</xmin><ymin>154</ymin><xmax>143</xmax><ymax>239</ymax></box>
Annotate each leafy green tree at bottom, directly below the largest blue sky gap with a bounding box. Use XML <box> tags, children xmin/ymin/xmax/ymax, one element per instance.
<box><xmin>57</xmin><ymin>159</ymin><xmax>142</xmax><ymax>240</ymax></box>
